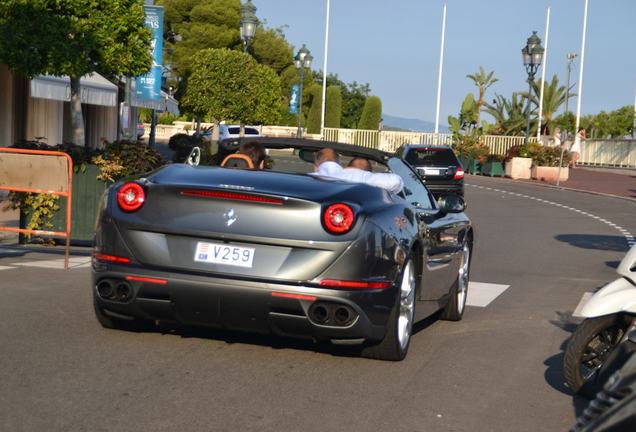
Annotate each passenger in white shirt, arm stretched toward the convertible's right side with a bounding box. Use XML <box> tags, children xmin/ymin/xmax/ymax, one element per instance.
<box><xmin>314</xmin><ymin>147</ymin><xmax>404</xmax><ymax>193</ymax></box>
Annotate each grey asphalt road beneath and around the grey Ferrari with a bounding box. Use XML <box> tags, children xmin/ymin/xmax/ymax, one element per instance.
<box><xmin>0</xmin><ymin>170</ymin><xmax>636</xmax><ymax>432</ymax></box>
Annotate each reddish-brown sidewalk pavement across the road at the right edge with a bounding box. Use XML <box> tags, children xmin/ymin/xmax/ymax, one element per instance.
<box><xmin>516</xmin><ymin>166</ymin><xmax>636</xmax><ymax>201</ymax></box>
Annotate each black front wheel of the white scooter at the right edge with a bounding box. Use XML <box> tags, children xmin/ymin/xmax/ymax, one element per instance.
<box><xmin>563</xmin><ymin>315</ymin><xmax>631</xmax><ymax>398</ymax></box>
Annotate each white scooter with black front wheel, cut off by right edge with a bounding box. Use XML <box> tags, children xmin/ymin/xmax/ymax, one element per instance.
<box><xmin>563</xmin><ymin>245</ymin><xmax>636</xmax><ymax>398</ymax></box>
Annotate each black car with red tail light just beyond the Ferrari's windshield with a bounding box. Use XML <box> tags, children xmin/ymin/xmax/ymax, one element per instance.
<box><xmin>396</xmin><ymin>144</ymin><xmax>464</xmax><ymax>197</ymax></box>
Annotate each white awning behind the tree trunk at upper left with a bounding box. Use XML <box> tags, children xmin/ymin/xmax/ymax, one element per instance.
<box><xmin>30</xmin><ymin>73</ymin><xmax>118</xmax><ymax>106</ymax></box>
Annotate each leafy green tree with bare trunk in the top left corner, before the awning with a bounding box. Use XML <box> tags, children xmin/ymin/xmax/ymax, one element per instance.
<box><xmin>0</xmin><ymin>0</ymin><xmax>152</xmax><ymax>146</ymax></box>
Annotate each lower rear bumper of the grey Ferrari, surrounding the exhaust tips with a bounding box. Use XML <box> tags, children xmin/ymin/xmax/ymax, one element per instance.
<box><xmin>92</xmin><ymin>265</ymin><xmax>397</xmax><ymax>343</ymax></box>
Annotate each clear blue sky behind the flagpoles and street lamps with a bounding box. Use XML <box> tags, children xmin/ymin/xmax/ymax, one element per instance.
<box><xmin>252</xmin><ymin>0</ymin><xmax>636</xmax><ymax>124</ymax></box>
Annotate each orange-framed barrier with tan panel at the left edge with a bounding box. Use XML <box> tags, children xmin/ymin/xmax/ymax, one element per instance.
<box><xmin>0</xmin><ymin>147</ymin><xmax>73</xmax><ymax>269</ymax></box>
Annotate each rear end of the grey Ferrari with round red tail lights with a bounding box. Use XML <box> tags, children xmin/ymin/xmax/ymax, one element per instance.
<box><xmin>92</xmin><ymin>164</ymin><xmax>399</xmax><ymax>344</ymax></box>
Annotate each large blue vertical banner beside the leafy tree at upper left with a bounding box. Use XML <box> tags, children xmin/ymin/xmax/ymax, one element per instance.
<box><xmin>135</xmin><ymin>5</ymin><xmax>163</xmax><ymax>101</ymax></box>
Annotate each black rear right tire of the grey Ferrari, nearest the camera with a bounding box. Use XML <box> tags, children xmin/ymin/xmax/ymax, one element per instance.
<box><xmin>361</xmin><ymin>259</ymin><xmax>417</xmax><ymax>361</ymax></box>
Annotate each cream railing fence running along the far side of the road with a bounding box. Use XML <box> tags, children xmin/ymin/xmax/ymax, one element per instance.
<box><xmin>145</xmin><ymin>122</ymin><xmax>636</xmax><ymax>168</ymax></box>
